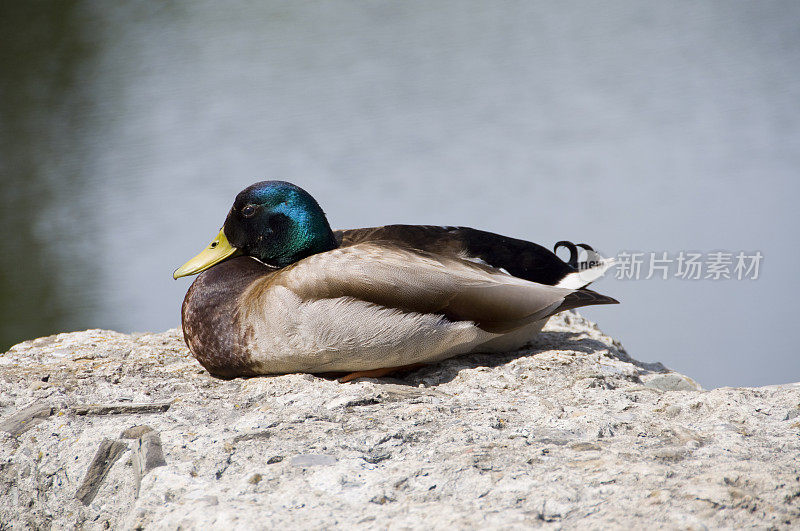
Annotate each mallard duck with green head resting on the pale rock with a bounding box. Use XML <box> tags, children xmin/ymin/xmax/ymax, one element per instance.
<box><xmin>173</xmin><ymin>181</ymin><xmax>617</xmax><ymax>379</ymax></box>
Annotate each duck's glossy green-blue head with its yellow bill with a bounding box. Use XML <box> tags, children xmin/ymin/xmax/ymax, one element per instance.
<box><xmin>173</xmin><ymin>181</ymin><xmax>337</xmax><ymax>278</ymax></box>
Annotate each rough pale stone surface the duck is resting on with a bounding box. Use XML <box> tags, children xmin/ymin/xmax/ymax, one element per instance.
<box><xmin>0</xmin><ymin>313</ymin><xmax>800</xmax><ymax>529</ymax></box>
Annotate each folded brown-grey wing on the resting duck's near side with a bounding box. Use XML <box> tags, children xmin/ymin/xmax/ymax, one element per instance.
<box><xmin>272</xmin><ymin>242</ymin><xmax>600</xmax><ymax>333</ymax></box>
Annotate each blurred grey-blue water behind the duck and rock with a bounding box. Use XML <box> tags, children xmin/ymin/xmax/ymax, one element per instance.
<box><xmin>0</xmin><ymin>0</ymin><xmax>800</xmax><ymax>387</ymax></box>
